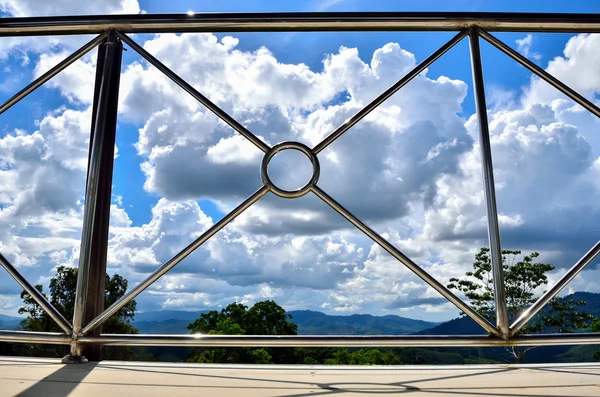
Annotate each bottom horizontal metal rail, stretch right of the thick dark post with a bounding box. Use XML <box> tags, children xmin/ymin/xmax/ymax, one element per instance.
<box><xmin>80</xmin><ymin>333</ymin><xmax>600</xmax><ymax>347</ymax></box>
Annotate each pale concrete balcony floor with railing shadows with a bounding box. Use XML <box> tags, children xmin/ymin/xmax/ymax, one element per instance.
<box><xmin>0</xmin><ymin>357</ymin><xmax>600</xmax><ymax>397</ymax></box>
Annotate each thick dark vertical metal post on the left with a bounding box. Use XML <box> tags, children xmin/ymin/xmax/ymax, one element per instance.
<box><xmin>65</xmin><ymin>30</ymin><xmax>123</xmax><ymax>362</ymax></box>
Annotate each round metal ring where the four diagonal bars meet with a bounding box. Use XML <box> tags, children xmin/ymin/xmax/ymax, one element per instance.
<box><xmin>260</xmin><ymin>142</ymin><xmax>321</xmax><ymax>198</ymax></box>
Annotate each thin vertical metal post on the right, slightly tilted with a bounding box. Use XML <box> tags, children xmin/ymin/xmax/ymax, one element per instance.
<box><xmin>469</xmin><ymin>28</ymin><xmax>510</xmax><ymax>339</ymax></box>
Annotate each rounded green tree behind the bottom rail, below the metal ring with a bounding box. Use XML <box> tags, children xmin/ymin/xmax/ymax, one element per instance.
<box><xmin>188</xmin><ymin>300</ymin><xmax>298</xmax><ymax>364</ymax></box>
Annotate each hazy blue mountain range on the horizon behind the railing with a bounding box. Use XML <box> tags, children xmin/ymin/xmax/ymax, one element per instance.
<box><xmin>0</xmin><ymin>292</ymin><xmax>600</xmax><ymax>364</ymax></box>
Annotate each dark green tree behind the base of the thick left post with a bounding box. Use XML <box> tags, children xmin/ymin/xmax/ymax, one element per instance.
<box><xmin>19</xmin><ymin>266</ymin><xmax>138</xmax><ymax>360</ymax></box>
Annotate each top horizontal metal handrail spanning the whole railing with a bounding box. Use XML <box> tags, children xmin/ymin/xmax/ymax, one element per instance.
<box><xmin>0</xmin><ymin>12</ymin><xmax>600</xmax><ymax>36</ymax></box>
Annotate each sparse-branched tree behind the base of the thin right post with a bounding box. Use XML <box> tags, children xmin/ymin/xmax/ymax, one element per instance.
<box><xmin>448</xmin><ymin>248</ymin><xmax>593</xmax><ymax>363</ymax></box>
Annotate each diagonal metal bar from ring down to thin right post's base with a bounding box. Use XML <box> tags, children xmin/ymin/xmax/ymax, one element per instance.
<box><xmin>311</xmin><ymin>185</ymin><xmax>501</xmax><ymax>336</ymax></box>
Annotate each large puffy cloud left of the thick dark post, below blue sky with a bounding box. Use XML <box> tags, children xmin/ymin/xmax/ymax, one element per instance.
<box><xmin>0</xmin><ymin>109</ymin><xmax>91</xmax><ymax>265</ymax></box>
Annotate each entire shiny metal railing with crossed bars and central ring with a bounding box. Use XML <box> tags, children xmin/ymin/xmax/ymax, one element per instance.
<box><xmin>0</xmin><ymin>13</ymin><xmax>600</xmax><ymax>360</ymax></box>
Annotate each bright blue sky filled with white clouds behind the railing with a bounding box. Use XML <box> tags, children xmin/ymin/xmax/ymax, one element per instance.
<box><xmin>0</xmin><ymin>0</ymin><xmax>600</xmax><ymax>321</ymax></box>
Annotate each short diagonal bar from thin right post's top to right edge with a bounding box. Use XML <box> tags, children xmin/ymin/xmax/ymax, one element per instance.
<box><xmin>477</xmin><ymin>28</ymin><xmax>600</xmax><ymax>117</ymax></box>
